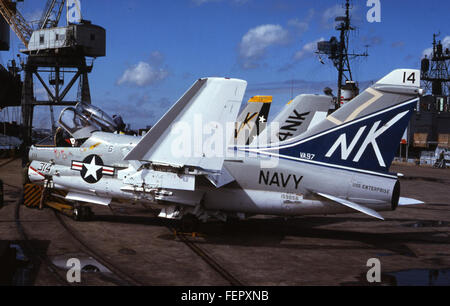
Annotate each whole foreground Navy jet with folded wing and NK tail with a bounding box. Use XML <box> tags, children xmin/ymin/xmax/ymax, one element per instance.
<box><xmin>28</xmin><ymin>69</ymin><xmax>422</xmax><ymax>221</ymax></box>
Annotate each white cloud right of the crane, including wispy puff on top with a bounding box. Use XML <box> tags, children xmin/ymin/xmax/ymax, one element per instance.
<box><xmin>117</xmin><ymin>51</ymin><xmax>169</xmax><ymax>87</ymax></box>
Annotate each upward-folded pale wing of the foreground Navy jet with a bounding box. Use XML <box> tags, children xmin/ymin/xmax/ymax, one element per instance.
<box><xmin>124</xmin><ymin>78</ymin><xmax>247</xmax><ymax>171</ymax></box>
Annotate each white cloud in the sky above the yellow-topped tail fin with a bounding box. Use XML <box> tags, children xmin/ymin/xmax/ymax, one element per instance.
<box><xmin>239</xmin><ymin>24</ymin><xmax>289</xmax><ymax>59</ymax></box>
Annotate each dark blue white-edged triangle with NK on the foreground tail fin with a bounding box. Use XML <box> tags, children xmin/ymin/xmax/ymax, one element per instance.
<box><xmin>236</xmin><ymin>98</ymin><xmax>418</xmax><ymax>176</ymax></box>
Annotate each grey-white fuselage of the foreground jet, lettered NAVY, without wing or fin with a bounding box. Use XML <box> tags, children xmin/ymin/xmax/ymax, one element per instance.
<box><xmin>29</xmin><ymin>132</ymin><xmax>399</xmax><ymax>216</ymax></box>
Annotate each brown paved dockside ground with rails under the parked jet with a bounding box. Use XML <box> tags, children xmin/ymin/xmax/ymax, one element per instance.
<box><xmin>0</xmin><ymin>161</ymin><xmax>450</xmax><ymax>286</ymax></box>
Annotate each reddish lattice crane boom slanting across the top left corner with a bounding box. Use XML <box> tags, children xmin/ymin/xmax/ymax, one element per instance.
<box><xmin>0</xmin><ymin>0</ymin><xmax>33</xmax><ymax>48</ymax></box>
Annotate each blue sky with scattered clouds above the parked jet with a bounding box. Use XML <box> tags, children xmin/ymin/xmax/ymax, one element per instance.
<box><xmin>1</xmin><ymin>0</ymin><xmax>450</xmax><ymax>128</ymax></box>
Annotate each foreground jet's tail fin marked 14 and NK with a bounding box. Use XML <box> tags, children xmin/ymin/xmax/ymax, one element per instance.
<box><xmin>258</xmin><ymin>69</ymin><xmax>422</xmax><ymax>173</ymax></box>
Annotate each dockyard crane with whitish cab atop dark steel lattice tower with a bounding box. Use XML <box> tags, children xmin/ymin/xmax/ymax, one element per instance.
<box><xmin>0</xmin><ymin>0</ymin><xmax>106</xmax><ymax>149</ymax></box>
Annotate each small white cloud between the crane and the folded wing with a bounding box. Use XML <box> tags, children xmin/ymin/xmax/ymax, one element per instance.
<box><xmin>117</xmin><ymin>62</ymin><xmax>169</xmax><ymax>87</ymax></box>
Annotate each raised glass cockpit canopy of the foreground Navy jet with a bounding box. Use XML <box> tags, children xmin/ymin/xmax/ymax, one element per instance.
<box><xmin>58</xmin><ymin>102</ymin><xmax>118</xmax><ymax>139</ymax></box>
